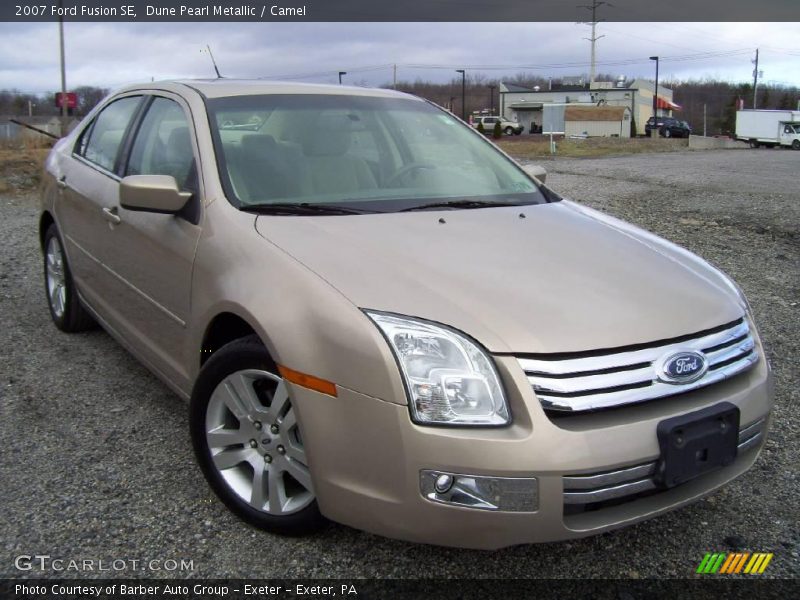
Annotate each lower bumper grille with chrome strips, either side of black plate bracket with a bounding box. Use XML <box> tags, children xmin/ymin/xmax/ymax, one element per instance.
<box><xmin>562</xmin><ymin>419</ymin><xmax>766</xmax><ymax>514</ymax></box>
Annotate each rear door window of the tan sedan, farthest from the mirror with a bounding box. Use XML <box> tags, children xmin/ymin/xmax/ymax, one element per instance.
<box><xmin>78</xmin><ymin>96</ymin><xmax>141</xmax><ymax>172</ymax></box>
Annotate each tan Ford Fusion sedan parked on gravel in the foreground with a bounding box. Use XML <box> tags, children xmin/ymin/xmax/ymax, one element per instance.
<box><xmin>39</xmin><ymin>79</ymin><xmax>772</xmax><ymax>548</ymax></box>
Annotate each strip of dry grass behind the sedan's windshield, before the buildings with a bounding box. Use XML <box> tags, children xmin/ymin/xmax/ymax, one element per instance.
<box><xmin>496</xmin><ymin>136</ymin><xmax>689</xmax><ymax>159</ymax></box>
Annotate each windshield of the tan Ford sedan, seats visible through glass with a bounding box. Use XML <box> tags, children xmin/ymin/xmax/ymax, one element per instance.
<box><xmin>207</xmin><ymin>94</ymin><xmax>559</xmax><ymax>214</ymax></box>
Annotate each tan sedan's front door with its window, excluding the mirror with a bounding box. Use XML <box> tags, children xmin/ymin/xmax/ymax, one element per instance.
<box><xmin>103</xmin><ymin>95</ymin><xmax>202</xmax><ymax>386</ymax></box>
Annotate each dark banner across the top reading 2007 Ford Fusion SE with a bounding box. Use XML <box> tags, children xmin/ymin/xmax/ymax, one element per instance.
<box><xmin>0</xmin><ymin>0</ymin><xmax>800</xmax><ymax>22</ymax></box>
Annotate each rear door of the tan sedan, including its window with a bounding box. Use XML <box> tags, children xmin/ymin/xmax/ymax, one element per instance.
<box><xmin>55</xmin><ymin>94</ymin><xmax>143</xmax><ymax>318</ymax></box>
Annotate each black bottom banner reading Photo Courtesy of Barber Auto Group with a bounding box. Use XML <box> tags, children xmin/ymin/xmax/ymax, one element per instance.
<box><xmin>0</xmin><ymin>576</ymin><xmax>799</xmax><ymax>600</ymax></box>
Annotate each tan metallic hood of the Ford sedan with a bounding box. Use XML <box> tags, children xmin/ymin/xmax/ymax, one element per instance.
<box><xmin>256</xmin><ymin>201</ymin><xmax>744</xmax><ymax>353</ymax></box>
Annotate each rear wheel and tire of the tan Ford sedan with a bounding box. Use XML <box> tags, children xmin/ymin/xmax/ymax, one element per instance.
<box><xmin>44</xmin><ymin>223</ymin><xmax>95</xmax><ymax>333</ymax></box>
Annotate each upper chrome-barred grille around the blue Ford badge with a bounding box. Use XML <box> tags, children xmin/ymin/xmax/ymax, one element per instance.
<box><xmin>517</xmin><ymin>318</ymin><xmax>758</xmax><ymax>413</ymax></box>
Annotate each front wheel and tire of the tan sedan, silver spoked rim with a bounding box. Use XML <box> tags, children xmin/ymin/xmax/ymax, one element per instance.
<box><xmin>189</xmin><ymin>336</ymin><xmax>325</xmax><ymax>535</ymax></box>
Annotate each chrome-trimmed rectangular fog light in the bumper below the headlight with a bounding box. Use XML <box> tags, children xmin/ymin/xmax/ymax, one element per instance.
<box><xmin>419</xmin><ymin>470</ymin><xmax>539</xmax><ymax>512</ymax></box>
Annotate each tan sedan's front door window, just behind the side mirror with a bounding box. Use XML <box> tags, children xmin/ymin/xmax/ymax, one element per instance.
<box><xmin>125</xmin><ymin>97</ymin><xmax>197</xmax><ymax>192</ymax></box>
